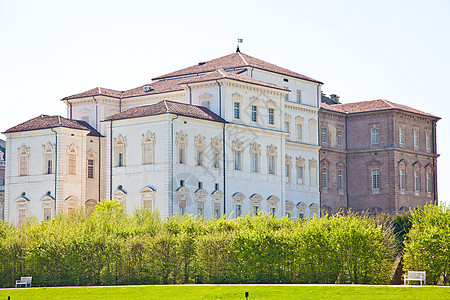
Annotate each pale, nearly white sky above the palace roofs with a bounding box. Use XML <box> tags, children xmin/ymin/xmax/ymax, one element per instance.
<box><xmin>0</xmin><ymin>0</ymin><xmax>450</xmax><ymax>203</ymax></box>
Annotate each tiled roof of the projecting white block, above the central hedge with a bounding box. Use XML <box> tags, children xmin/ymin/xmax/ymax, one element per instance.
<box><xmin>105</xmin><ymin>100</ymin><xmax>225</xmax><ymax>123</ymax></box>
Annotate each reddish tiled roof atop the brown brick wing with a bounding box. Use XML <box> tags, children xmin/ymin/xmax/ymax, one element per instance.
<box><xmin>322</xmin><ymin>99</ymin><xmax>440</xmax><ymax>119</ymax></box>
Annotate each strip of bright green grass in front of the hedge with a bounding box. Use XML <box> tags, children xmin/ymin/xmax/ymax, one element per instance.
<box><xmin>0</xmin><ymin>285</ymin><xmax>450</xmax><ymax>300</ymax></box>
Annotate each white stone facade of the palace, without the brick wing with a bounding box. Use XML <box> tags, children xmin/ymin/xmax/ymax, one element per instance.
<box><xmin>5</xmin><ymin>54</ymin><xmax>321</xmax><ymax>222</ymax></box>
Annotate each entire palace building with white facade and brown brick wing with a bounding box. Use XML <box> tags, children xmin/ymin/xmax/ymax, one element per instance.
<box><xmin>2</xmin><ymin>51</ymin><xmax>438</xmax><ymax>223</ymax></box>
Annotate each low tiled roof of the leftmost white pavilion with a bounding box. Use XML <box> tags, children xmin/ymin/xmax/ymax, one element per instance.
<box><xmin>5</xmin><ymin>115</ymin><xmax>101</xmax><ymax>136</ymax></box>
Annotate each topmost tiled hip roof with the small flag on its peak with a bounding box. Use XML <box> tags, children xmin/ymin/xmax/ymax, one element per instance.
<box><xmin>153</xmin><ymin>52</ymin><xmax>322</xmax><ymax>83</ymax></box>
